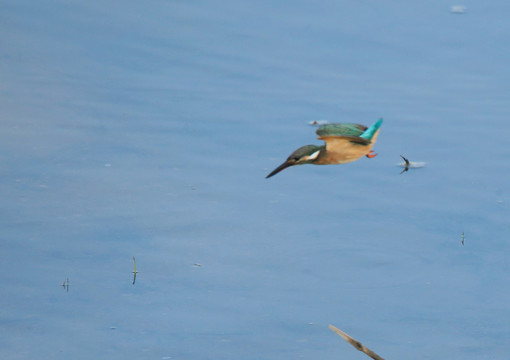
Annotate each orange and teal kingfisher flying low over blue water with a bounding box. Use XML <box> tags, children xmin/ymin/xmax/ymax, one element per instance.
<box><xmin>266</xmin><ymin>119</ymin><xmax>383</xmax><ymax>179</ymax></box>
